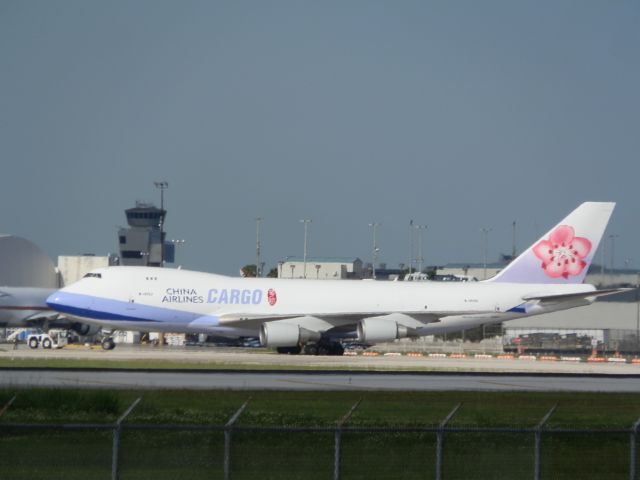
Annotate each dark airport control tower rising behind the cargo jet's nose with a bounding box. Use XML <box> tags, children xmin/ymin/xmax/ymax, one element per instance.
<box><xmin>118</xmin><ymin>202</ymin><xmax>175</xmax><ymax>267</ymax></box>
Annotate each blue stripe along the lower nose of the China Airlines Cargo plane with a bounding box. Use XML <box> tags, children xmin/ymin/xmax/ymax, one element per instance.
<box><xmin>47</xmin><ymin>292</ymin><xmax>218</xmax><ymax>325</ymax></box>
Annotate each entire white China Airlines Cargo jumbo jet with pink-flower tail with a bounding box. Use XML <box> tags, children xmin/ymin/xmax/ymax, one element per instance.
<box><xmin>47</xmin><ymin>202</ymin><xmax>618</xmax><ymax>354</ymax></box>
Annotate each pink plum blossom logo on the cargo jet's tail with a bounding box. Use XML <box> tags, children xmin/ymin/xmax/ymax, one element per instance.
<box><xmin>533</xmin><ymin>225</ymin><xmax>591</xmax><ymax>279</ymax></box>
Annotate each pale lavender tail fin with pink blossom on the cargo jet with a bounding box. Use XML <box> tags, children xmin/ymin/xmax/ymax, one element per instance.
<box><xmin>488</xmin><ymin>202</ymin><xmax>616</xmax><ymax>283</ymax></box>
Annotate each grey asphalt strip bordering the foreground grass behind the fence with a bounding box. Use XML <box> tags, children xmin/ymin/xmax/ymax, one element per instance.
<box><xmin>0</xmin><ymin>369</ymin><xmax>640</xmax><ymax>393</ymax></box>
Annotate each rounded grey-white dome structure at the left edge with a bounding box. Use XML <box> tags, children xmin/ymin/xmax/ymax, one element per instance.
<box><xmin>0</xmin><ymin>235</ymin><xmax>58</xmax><ymax>288</ymax></box>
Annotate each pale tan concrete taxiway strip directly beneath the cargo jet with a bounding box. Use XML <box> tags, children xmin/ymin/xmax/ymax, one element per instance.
<box><xmin>0</xmin><ymin>345</ymin><xmax>640</xmax><ymax>375</ymax></box>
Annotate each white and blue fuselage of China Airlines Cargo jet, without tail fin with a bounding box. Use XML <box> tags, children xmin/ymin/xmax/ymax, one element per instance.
<box><xmin>48</xmin><ymin>267</ymin><xmax>594</xmax><ymax>335</ymax></box>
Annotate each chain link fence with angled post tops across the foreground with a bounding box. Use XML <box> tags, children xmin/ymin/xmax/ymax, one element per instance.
<box><xmin>0</xmin><ymin>399</ymin><xmax>640</xmax><ymax>480</ymax></box>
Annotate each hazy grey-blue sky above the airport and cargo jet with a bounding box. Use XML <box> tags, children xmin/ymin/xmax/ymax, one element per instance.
<box><xmin>0</xmin><ymin>0</ymin><xmax>640</xmax><ymax>274</ymax></box>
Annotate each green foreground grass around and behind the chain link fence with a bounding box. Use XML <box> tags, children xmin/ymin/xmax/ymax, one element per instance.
<box><xmin>0</xmin><ymin>389</ymin><xmax>640</xmax><ymax>480</ymax></box>
